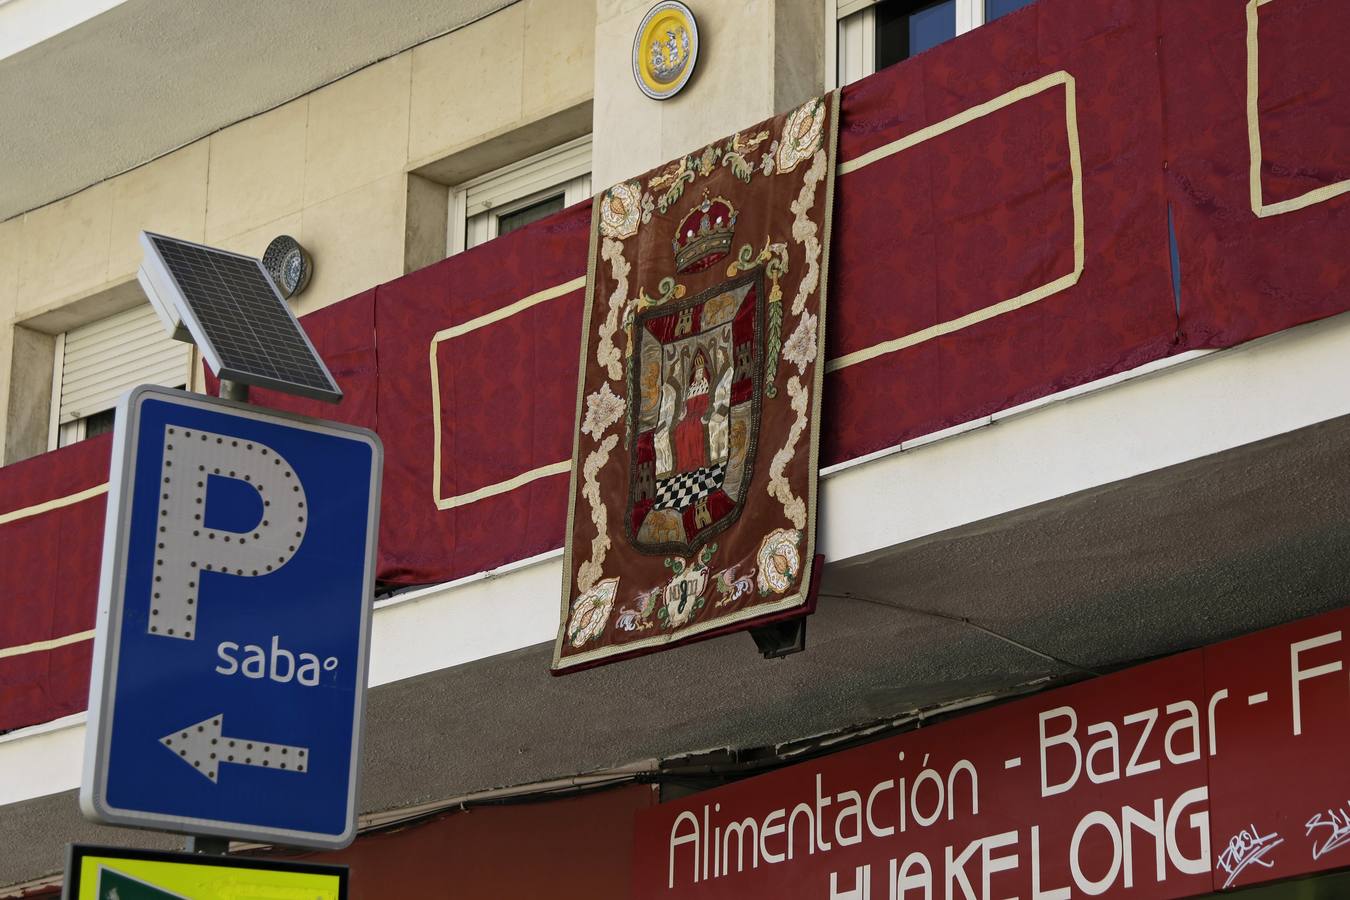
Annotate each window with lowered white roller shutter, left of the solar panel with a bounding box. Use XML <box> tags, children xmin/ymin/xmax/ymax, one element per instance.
<box><xmin>47</xmin><ymin>304</ymin><xmax>192</xmax><ymax>449</ymax></box>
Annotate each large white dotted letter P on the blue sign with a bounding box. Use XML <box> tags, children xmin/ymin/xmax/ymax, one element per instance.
<box><xmin>147</xmin><ymin>426</ymin><xmax>306</xmax><ymax>641</ymax></box>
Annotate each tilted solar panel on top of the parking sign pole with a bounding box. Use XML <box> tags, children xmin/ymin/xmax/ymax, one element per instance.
<box><xmin>136</xmin><ymin>232</ymin><xmax>342</xmax><ymax>403</ymax></box>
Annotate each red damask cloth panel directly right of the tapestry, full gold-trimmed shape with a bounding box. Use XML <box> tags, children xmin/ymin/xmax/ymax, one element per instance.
<box><xmin>822</xmin><ymin>0</ymin><xmax>1182</xmax><ymax>463</ymax></box>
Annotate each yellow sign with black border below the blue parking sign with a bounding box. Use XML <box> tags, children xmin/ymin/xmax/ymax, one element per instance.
<box><xmin>65</xmin><ymin>845</ymin><xmax>347</xmax><ymax>900</ymax></box>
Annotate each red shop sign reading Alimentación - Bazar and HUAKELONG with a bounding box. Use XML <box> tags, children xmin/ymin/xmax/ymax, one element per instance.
<box><xmin>633</xmin><ymin>609</ymin><xmax>1350</xmax><ymax>900</ymax></box>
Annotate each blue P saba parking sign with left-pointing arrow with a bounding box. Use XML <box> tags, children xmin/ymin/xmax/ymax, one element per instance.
<box><xmin>80</xmin><ymin>386</ymin><xmax>383</xmax><ymax>847</ymax></box>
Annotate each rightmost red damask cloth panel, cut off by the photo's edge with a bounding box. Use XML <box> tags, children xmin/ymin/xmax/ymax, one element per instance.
<box><xmin>1160</xmin><ymin>0</ymin><xmax>1350</xmax><ymax>347</ymax></box>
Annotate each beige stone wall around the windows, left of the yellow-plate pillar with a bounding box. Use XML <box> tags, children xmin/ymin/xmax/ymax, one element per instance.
<box><xmin>0</xmin><ymin>0</ymin><xmax>595</xmax><ymax>461</ymax></box>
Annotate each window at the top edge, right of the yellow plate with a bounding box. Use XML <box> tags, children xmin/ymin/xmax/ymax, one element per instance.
<box><xmin>836</xmin><ymin>0</ymin><xmax>1034</xmax><ymax>85</ymax></box>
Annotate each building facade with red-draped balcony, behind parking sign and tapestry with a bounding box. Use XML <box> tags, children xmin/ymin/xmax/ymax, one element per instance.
<box><xmin>0</xmin><ymin>0</ymin><xmax>1350</xmax><ymax>899</ymax></box>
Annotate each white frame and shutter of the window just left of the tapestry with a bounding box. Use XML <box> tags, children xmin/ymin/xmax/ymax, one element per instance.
<box><xmin>446</xmin><ymin>135</ymin><xmax>591</xmax><ymax>255</ymax></box>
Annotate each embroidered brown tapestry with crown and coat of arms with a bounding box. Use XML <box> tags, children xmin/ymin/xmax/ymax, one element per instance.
<box><xmin>554</xmin><ymin>94</ymin><xmax>838</xmax><ymax>671</ymax></box>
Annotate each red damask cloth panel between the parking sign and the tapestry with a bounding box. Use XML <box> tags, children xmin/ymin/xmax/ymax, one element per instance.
<box><xmin>375</xmin><ymin>204</ymin><xmax>590</xmax><ymax>584</ymax></box>
